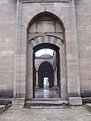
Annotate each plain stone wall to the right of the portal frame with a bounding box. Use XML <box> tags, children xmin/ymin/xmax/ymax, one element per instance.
<box><xmin>75</xmin><ymin>0</ymin><xmax>91</xmax><ymax>96</ymax></box>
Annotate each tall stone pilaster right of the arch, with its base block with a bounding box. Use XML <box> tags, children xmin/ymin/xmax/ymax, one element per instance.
<box><xmin>67</xmin><ymin>0</ymin><xmax>82</xmax><ymax>105</ymax></box>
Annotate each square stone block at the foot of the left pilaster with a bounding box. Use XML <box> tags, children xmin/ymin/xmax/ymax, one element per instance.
<box><xmin>11</xmin><ymin>98</ymin><xmax>25</xmax><ymax>109</ymax></box>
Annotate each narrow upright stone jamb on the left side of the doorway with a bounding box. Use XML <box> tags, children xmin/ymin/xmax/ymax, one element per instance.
<box><xmin>26</xmin><ymin>42</ymin><xmax>33</xmax><ymax>99</ymax></box>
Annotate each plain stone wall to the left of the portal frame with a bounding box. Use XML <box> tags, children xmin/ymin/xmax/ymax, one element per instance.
<box><xmin>0</xmin><ymin>0</ymin><xmax>16</xmax><ymax>97</ymax></box>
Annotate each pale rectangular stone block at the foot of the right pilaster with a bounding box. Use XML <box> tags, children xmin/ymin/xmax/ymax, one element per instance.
<box><xmin>69</xmin><ymin>97</ymin><xmax>82</xmax><ymax>106</ymax></box>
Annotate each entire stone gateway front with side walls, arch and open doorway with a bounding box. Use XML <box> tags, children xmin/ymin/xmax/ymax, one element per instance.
<box><xmin>0</xmin><ymin>0</ymin><xmax>91</xmax><ymax>105</ymax></box>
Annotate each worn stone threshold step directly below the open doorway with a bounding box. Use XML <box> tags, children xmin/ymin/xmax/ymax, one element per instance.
<box><xmin>25</xmin><ymin>100</ymin><xmax>68</xmax><ymax>108</ymax></box>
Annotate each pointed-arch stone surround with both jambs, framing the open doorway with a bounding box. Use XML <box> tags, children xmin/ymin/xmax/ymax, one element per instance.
<box><xmin>26</xmin><ymin>12</ymin><xmax>67</xmax><ymax>98</ymax></box>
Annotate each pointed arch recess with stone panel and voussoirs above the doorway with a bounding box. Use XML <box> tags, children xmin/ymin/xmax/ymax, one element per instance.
<box><xmin>27</xmin><ymin>12</ymin><xmax>65</xmax><ymax>47</ymax></box>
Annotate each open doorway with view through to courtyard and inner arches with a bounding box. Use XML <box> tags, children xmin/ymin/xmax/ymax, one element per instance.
<box><xmin>33</xmin><ymin>43</ymin><xmax>61</xmax><ymax>99</ymax></box>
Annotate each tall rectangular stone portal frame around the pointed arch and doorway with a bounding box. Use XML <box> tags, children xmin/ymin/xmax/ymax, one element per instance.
<box><xmin>14</xmin><ymin>1</ymin><xmax>80</xmax><ymax>105</ymax></box>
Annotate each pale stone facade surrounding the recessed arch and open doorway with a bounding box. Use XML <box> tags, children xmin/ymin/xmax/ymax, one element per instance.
<box><xmin>0</xmin><ymin>0</ymin><xmax>91</xmax><ymax>105</ymax></box>
